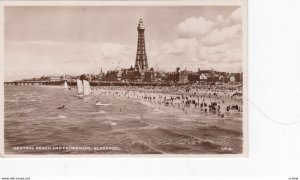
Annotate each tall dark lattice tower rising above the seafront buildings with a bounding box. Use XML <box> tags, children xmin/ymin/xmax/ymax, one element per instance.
<box><xmin>135</xmin><ymin>18</ymin><xmax>148</xmax><ymax>70</ymax></box>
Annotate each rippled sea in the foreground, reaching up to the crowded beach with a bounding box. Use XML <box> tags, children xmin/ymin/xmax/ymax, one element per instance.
<box><xmin>4</xmin><ymin>86</ymin><xmax>243</xmax><ymax>155</ymax></box>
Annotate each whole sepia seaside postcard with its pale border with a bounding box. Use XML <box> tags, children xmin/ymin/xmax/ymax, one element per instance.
<box><xmin>3</xmin><ymin>1</ymin><xmax>248</xmax><ymax>157</ymax></box>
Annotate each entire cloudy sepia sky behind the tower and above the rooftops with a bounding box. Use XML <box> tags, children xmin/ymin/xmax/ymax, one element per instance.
<box><xmin>4</xmin><ymin>6</ymin><xmax>242</xmax><ymax>81</ymax></box>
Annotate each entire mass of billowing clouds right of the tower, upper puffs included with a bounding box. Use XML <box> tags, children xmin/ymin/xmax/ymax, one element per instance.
<box><xmin>160</xmin><ymin>8</ymin><xmax>242</xmax><ymax>72</ymax></box>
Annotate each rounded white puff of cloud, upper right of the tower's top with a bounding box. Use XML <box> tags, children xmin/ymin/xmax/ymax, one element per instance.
<box><xmin>177</xmin><ymin>17</ymin><xmax>214</xmax><ymax>37</ymax></box>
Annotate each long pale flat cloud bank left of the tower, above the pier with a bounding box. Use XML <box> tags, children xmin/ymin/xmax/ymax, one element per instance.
<box><xmin>5</xmin><ymin>41</ymin><xmax>136</xmax><ymax>79</ymax></box>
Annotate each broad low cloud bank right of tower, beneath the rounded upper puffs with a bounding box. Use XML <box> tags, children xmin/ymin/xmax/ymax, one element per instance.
<box><xmin>160</xmin><ymin>38</ymin><xmax>242</xmax><ymax>72</ymax></box>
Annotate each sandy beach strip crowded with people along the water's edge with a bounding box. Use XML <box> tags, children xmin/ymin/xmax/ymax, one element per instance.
<box><xmin>95</xmin><ymin>86</ymin><xmax>243</xmax><ymax>118</ymax></box>
